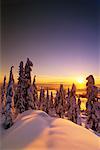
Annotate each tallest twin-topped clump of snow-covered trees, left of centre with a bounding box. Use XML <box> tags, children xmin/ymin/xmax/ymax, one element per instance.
<box><xmin>14</xmin><ymin>58</ymin><xmax>34</xmax><ymax>113</ymax></box>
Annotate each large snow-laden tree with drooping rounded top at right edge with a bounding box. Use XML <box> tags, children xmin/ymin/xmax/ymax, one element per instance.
<box><xmin>86</xmin><ymin>75</ymin><xmax>100</xmax><ymax>132</ymax></box>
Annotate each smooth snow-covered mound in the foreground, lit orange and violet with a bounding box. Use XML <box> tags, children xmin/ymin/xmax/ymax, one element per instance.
<box><xmin>0</xmin><ymin>110</ymin><xmax>100</xmax><ymax>150</ymax></box>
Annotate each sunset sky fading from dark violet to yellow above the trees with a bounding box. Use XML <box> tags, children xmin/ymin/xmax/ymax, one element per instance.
<box><xmin>0</xmin><ymin>0</ymin><xmax>100</xmax><ymax>85</ymax></box>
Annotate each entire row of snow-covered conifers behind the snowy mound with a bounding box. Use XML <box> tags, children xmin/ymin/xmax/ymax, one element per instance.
<box><xmin>1</xmin><ymin>58</ymin><xmax>100</xmax><ymax>132</ymax></box>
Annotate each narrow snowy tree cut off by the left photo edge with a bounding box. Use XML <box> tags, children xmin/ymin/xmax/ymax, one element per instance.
<box><xmin>1</xmin><ymin>76</ymin><xmax>6</xmax><ymax>116</ymax></box>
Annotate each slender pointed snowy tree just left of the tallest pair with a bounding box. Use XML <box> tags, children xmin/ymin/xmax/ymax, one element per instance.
<box><xmin>4</xmin><ymin>66</ymin><xmax>14</xmax><ymax>129</ymax></box>
